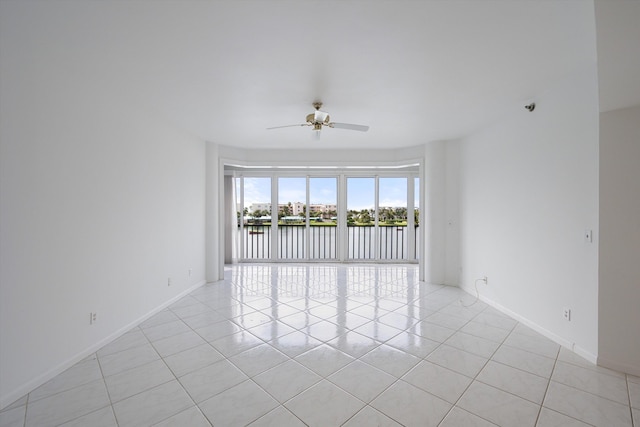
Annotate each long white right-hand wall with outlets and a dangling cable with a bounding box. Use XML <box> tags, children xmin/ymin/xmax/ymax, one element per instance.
<box><xmin>450</xmin><ymin>68</ymin><xmax>598</xmax><ymax>361</ymax></box>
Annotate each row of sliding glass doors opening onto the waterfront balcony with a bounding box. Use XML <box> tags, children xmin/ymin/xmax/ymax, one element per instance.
<box><xmin>235</xmin><ymin>172</ymin><xmax>420</xmax><ymax>262</ymax></box>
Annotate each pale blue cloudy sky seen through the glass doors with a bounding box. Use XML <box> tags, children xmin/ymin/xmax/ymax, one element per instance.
<box><xmin>238</xmin><ymin>177</ymin><xmax>419</xmax><ymax>210</ymax></box>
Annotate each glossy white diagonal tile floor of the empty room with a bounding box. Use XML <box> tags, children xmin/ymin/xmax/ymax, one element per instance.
<box><xmin>0</xmin><ymin>264</ymin><xmax>640</xmax><ymax>427</ymax></box>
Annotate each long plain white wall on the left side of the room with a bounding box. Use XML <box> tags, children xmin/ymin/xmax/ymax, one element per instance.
<box><xmin>0</xmin><ymin>20</ymin><xmax>205</xmax><ymax>406</ymax></box>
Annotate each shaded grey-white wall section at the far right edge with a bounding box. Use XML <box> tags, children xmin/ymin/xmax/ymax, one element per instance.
<box><xmin>598</xmin><ymin>106</ymin><xmax>640</xmax><ymax>375</ymax></box>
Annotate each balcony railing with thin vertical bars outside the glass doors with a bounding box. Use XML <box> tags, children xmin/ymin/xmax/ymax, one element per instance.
<box><xmin>242</xmin><ymin>224</ymin><xmax>419</xmax><ymax>260</ymax></box>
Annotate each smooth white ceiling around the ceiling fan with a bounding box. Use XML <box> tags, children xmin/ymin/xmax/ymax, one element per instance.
<box><xmin>6</xmin><ymin>0</ymin><xmax>596</xmax><ymax>148</ymax></box>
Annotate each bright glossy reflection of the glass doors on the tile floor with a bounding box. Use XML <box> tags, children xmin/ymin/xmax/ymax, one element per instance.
<box><xmin>218</xmin><ymin>264</ymin><xmax>428</xmax><ymax>342</ymax></box>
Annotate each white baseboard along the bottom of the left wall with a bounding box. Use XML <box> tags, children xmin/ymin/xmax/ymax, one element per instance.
<box><xmin>0</xmin><ymin>280</ymin><xmax>207</xmax><ymax>409</ymax></box>
